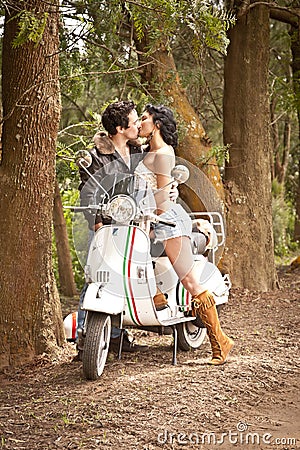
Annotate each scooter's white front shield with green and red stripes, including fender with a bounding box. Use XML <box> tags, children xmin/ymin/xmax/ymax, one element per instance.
<box><xmin>83</xmin><ymin>225</ymin><xmax>163</xmax><ymax>326</ymax></box>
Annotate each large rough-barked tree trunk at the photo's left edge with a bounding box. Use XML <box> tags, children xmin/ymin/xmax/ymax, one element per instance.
<box><xmin>0</xmin><ymin>0</ymin><xmax>64</xmax><ymax>367</ymax></box>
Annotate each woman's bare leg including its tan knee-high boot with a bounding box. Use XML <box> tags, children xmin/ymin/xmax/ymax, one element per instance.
<box><xmin>164</xmin><ymin>236</ymin><xmax>233</xmax><ymax>365</ymax></box>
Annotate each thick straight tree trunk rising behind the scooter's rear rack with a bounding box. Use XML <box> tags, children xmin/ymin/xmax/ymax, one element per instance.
<box><xmin>223</xmin><ymin>2</ymin><xmax>276</xmax><ymax>291</ymax></box>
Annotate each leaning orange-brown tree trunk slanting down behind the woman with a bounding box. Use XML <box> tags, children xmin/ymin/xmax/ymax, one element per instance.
<box><xmin>136</xmin><ymin>35</ymin><xmax>224</xmax><ymax>212</ymax></box>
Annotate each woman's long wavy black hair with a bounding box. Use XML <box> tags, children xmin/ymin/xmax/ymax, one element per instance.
<box><xmin>145</xmin><ymin>104</ymin><xmax>178</xmax><ymax>150</ymax></box>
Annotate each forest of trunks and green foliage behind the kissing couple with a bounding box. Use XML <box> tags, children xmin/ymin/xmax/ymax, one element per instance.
<box><xmin>0</xmin><ymin>0</ymin><xmax>300</xmax><ymax>366</ymax></box>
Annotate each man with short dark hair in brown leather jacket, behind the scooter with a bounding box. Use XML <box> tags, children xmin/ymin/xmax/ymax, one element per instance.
<box><xmin>78</xmin><ymin>101</ymin><xmax>173</xmax><ymax>352</ymax></box>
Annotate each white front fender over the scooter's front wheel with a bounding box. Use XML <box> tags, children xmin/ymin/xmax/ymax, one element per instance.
<box><xmin>82</xmin><ymin>283</ymin><xmax>124</xmax><ymax>315</ymax></box>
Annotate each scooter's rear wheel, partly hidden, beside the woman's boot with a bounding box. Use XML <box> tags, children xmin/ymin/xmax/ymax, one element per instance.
<box><xmin>177</xmin><ymin>321</ymin><xmax>206</xmax><ymax>352</ymax></box>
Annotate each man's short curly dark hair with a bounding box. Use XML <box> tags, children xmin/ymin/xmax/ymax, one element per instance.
<box><xmin>102</xmin><ymin>101</ymin><xmax>135</xmax><ymax>136</ymax></box>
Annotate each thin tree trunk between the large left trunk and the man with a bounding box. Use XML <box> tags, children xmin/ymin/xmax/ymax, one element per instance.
<box><xmin>53</xmin><ymin>182</ymin><xmax>78</xmax><ymax>297</ymax></box>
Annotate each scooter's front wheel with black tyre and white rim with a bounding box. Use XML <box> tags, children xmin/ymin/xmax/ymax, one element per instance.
<box><xmin>82</xmin><ymin>312</ymin><xmax>111</xmax><ymax>380</ymax></box>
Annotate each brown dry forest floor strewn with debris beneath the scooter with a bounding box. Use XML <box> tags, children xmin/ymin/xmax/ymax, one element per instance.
<box><xmin>0</xmin><ymin>268</ymin><xmax>300</xmax><ymax>450</ymax></box>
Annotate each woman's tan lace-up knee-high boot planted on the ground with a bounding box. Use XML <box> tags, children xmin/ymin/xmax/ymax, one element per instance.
<box><xmin>193</xmin><ymin>291</ymin><xmax>234</xmax><ymax>366</ymax></box>
